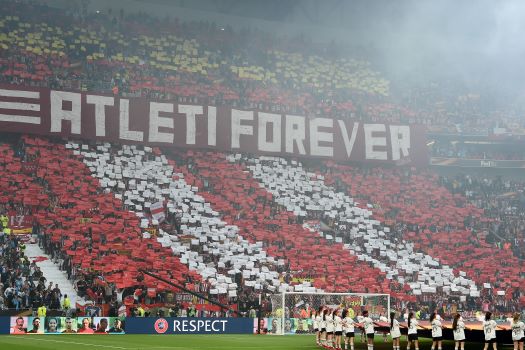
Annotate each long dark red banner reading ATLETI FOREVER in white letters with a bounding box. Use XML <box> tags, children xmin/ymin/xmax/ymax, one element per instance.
<box><xmin>0</xmin><ymin>85</ymin><xmax>427</xmax><ymax>165</ymax></box>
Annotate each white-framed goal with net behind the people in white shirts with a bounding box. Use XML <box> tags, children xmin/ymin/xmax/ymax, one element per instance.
<box><xmin>268</xmin><ymin>292</ymin><xmax>390</xmax><ymax>334</ymax></box>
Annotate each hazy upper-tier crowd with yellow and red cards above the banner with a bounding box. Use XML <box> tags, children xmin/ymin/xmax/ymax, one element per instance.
<box><xmin>0</xmin><ymin>0</ymin><xmax>521</xmax><ymax>134</ymax></box>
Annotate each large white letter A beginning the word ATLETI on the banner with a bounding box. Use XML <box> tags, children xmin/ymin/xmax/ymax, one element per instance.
<box><xmin>50</xmin><ymin>90</ymin><xmax>81</xmax><ymax>134</ymax></box>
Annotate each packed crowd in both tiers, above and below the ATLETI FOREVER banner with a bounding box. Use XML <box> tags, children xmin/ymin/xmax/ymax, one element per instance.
<box><xmin>0</xmin><ymin>1</ymin><xmax>525</xmax><ymax>320</ymax></box>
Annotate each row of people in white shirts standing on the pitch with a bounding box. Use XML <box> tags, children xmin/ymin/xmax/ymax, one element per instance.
<box><xmin>311</xmin><ymin>307</ymin><xmax>525</xmax><ymax>350</ymax></box>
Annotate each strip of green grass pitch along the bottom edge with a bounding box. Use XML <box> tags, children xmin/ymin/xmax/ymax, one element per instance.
<box><xmin>0</xmin><ymin>335</ymin><xmax>512</xmax><ymax>350</ymax></box>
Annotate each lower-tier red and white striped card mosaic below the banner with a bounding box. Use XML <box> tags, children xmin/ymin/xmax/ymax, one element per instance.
<box><xmin>3</xmin><ymin>137</ymin><xmax>521</xmax><ymax>316</ymax></box>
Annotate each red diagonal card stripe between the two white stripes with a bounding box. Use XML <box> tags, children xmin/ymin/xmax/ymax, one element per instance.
<box><xmin>168</xmin><ymin>152</ymin><xmax>388</xmax><ymax>291</ymax></box>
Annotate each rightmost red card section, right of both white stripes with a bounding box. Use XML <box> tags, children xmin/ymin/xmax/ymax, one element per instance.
<box><xmin>326</xmin><ymin>164</ymin><xmax>523</xmax><ymax>310</ymax></box>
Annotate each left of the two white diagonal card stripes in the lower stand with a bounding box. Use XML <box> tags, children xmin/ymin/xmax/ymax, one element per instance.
<box><xmin>68</xmin><ymin>143</ymin><xmax>266</xmax><ymax>312</ymax></box>
